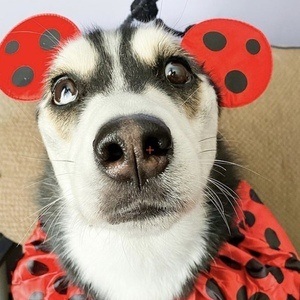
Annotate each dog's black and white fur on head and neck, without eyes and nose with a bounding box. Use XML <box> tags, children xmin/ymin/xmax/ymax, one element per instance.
<box><xmin>38</xmin><ymin>24</ymin><xmax>238</xmax><ymax>300</ymax></box>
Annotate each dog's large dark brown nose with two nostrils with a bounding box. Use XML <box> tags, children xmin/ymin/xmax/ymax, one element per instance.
<box><xmin>93</xmin><ymin>114</ymin><xmax>173</xmax><ymax>188</ymax></box>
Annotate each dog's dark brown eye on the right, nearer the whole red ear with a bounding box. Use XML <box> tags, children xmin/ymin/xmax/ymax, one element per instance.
<box><xmin>165</xmin><ymin>62</ymin><xmax>192</xmax><ymax>84</ymax></box>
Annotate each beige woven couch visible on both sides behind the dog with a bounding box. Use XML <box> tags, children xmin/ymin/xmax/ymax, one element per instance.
<box><xmin>0</xmin><ymin>49</ymin><xmax>300</xmax><ymax>251</ymax></box>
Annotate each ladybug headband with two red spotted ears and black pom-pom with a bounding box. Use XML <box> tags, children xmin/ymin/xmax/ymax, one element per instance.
<box><xmin>0</xmin><ymin>0</ymin><xmax>272</xmax><ymax>107</ymax></box>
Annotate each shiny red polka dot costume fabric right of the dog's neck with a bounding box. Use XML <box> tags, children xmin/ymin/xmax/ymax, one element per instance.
<box><xmin>188</xmin><ymin>181</ymin><xmax>300</xmax><ymax>300</ymax></box>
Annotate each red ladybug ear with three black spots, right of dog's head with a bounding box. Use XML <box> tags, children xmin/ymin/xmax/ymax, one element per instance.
<box><xmin>182</xmin><ymin>19</ymin><xmax>272</xmax><ymax>107</ymax></box>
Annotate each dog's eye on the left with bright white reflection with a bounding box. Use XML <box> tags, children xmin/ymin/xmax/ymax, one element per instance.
<box><xmin>53</xmin><ymin>77</ymin><xmax>78</xmax><ymax>105</ymax></box>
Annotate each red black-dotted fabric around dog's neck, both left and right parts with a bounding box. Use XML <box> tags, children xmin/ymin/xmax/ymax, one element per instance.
<box><xmin>11</xmin><ymin>181</ymin><xmax>300</xmax><ymax>300</ymax></box>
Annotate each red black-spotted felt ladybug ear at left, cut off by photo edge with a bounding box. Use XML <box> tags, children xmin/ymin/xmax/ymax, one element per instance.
<box><xmin>0</xmin><ymin>14</ymin><xmax>80</xmax><ymax>101</ymax></box>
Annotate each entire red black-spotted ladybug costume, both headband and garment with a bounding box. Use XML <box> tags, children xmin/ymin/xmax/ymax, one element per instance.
<box><xmin>0</xmin><ymin>0</ymin><xmax>300</xmax><ymax>300</ymax></box>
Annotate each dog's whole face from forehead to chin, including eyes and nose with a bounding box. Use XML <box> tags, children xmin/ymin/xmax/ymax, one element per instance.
<box><xmin>38</xmin><ymin>25</ymin><xmax>218</xmax><ymax>232</ymax></box>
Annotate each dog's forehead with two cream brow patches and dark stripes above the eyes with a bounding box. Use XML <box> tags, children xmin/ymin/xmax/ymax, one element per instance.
<box><xmin>50</xmin><ymin>24</ymin><xmax>182</xmax><ymax>77</ymax></box>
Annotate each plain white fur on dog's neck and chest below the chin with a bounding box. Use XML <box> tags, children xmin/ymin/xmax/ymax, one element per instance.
<box><xmin>65</xmin><ymin>199</ymin><xmax>207</xmax><ymax>300</ymax></box>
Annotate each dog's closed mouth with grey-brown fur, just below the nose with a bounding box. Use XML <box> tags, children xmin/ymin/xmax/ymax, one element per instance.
<box><xmin>99</xmin><ymin>178</ymin><xmax>185</xmax><ymax>225</ymax></box>
